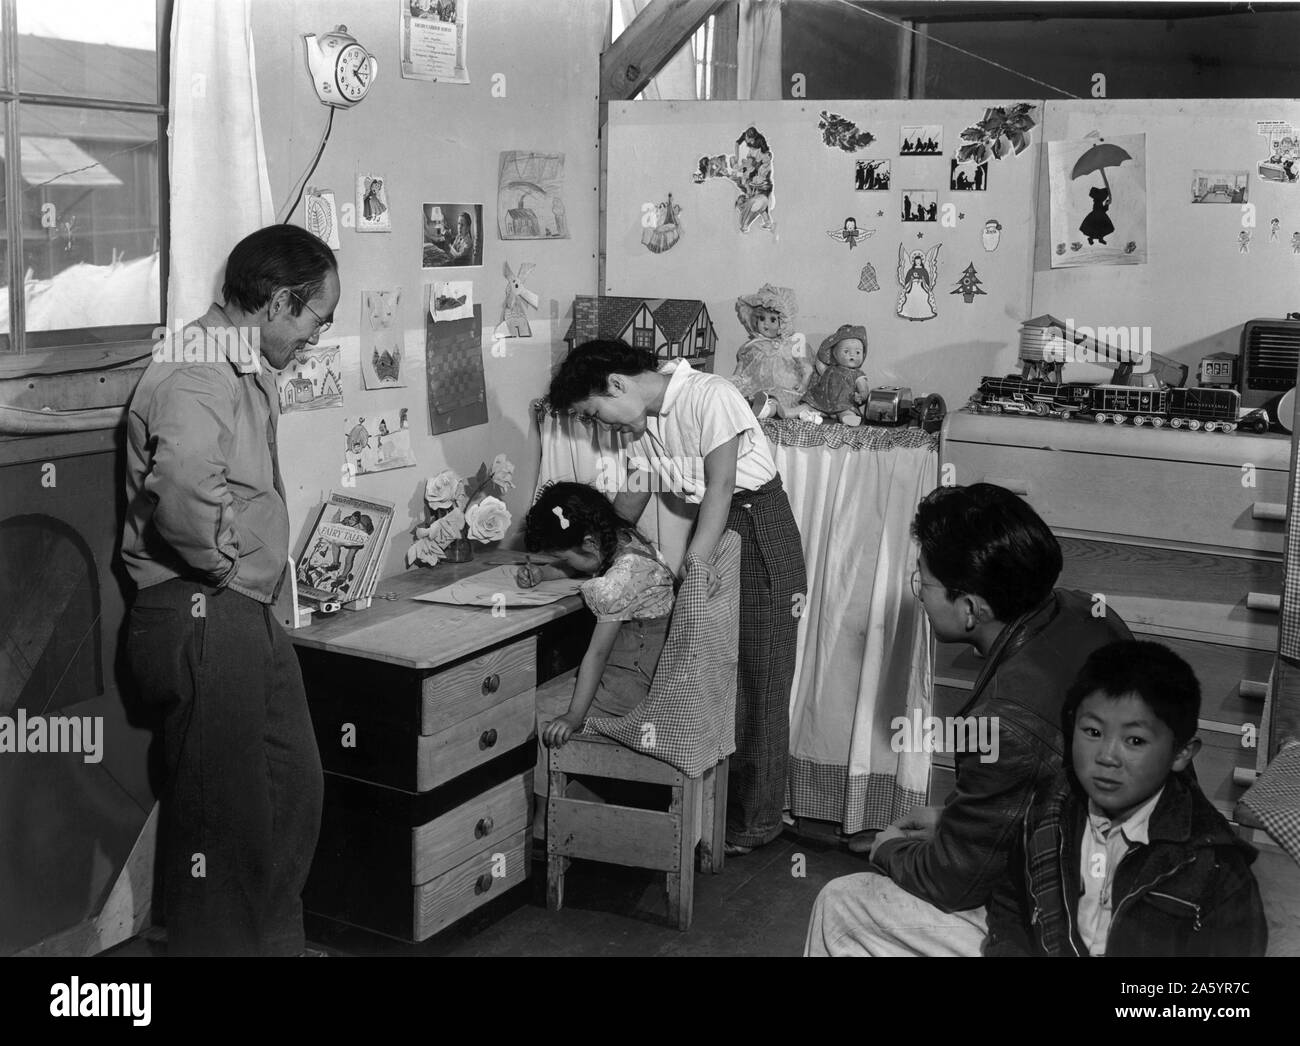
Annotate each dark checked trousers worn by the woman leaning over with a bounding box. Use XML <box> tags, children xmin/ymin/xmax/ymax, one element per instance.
<box><xmin>727</xmin><ymin>476</ymin><xmax>807</xmax><ymax>846</ymax></box>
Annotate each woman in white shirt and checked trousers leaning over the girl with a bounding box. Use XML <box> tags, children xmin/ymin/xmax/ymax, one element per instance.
<box><xmin>550</xmin><ymin>340</ymin><xmax>807</xmax><ymax>854</ymax></box>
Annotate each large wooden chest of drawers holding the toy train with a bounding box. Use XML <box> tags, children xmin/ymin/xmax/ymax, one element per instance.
<box><xmin>931</xmin><ymin>411</ymin><xmax>1291</xmax><ymax>819</ymax></box>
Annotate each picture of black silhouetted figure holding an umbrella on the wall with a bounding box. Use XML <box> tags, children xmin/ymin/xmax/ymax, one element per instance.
<box><xmin>1048</xmin><ymin>134</ymin><xmax>1147</xmax><ymax>269</ymax></box>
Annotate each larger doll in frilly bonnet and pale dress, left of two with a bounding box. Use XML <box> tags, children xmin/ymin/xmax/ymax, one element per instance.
<box><xmin>731</xmin><ymin>283</ymin><xmax>813</xmax><ymax>417</ymax></box>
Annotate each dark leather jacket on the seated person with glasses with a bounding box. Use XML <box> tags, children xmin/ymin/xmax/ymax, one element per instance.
<box><xmin>875</xmin><ymin>589</ymin><xmax>1132</xmax><ymax>912</ymax></box>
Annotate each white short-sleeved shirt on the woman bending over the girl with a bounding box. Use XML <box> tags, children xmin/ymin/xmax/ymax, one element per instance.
<box><xmin>628</xmin><ymin>360</ymin><xmax>776</xmax><ymax>504</ymax></box>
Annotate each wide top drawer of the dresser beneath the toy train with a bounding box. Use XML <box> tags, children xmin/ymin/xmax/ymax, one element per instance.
<box><xmin>945</xmin><ymin>433</ymin><xmax>1287</xmax><ymax>555</ymax></box>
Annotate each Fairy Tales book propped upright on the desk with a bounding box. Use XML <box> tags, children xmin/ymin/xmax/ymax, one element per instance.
<box><xmin>298</xmin><ymin>490</ymin><xmax>393</xmax><ymax>603</ymax></box>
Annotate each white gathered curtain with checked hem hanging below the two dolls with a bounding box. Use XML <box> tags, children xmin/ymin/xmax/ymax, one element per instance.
<box><xmin>775</xmin><ymin>444</ymin><xmax>939</xmax><ymax>833</ymax></box>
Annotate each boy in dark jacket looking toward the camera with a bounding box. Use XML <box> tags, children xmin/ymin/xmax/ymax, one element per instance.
<box><xmin>984</xmin><ymin>642</ymin><xmax>1268</xmax><ymax>955</ymax></box>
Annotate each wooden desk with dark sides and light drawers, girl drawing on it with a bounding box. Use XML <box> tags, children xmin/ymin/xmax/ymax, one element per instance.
<box><xmin>291</xmin><ymin>552</ymin><xmax>589</xmax><ymax>941</ymax></box>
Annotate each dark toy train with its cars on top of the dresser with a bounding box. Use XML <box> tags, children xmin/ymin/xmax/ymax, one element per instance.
<box><xmin>970</xmin><ymin>374</ymin><xmax>1269</xmax><ymax>433</ymax></box>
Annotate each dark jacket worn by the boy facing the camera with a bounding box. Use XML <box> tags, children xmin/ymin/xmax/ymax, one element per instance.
<box><xmin>984</xmin><ymin>771</ymin><xmax>1269</xmax><ymax>956</ymax></box>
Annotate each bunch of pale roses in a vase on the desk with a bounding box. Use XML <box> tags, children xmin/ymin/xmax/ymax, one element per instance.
<box><xmin>407</xmin><ymin>453</ymin><xmax>515</xmax><ymax>567</ymax></box>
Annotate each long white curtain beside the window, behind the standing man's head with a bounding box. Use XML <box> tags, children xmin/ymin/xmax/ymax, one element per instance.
<box><xmin>168</xmin><ymin>0</ymin><xmax>276</xmax><ymax>325</ymax></box>
